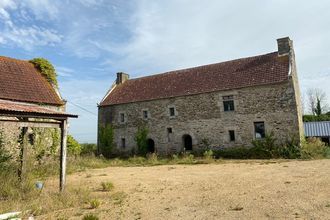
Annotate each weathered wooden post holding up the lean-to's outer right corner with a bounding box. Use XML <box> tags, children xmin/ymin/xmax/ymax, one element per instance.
<box><xmin>60</xmin><ymin>120</ymin><xmax>67</xmax><ymax>192</ymax></box>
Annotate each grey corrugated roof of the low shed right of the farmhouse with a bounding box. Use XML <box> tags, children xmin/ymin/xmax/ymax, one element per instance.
<box><xmin>304</xmin><ymin>121</ymin><xmax>330</xmax><ymax>137</ymax></box>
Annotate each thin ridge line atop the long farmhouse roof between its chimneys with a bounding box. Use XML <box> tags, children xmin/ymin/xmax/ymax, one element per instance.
<box><xmin>126</xmin><ymin>51</ymin><xmax>277</xmax><ymax>82</ymax></box>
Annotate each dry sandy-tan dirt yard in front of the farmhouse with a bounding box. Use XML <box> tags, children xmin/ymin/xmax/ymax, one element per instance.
<box><xmin>40</xmin><ymin>160</ymin><xmax>330</xmax><ymax>220</ymax></box>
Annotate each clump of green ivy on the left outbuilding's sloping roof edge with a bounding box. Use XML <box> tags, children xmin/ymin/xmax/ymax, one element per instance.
<box><xmin>29</xmin><ymin>58</ymin><xmax>58</xmax><ymax>88</ymax></box>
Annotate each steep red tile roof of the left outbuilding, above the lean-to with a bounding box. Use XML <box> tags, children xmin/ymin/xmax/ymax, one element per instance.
<box><xmin>0</xmin><ymin>56</ymin><xmax>64</xmax><ymax>105</ymax></box>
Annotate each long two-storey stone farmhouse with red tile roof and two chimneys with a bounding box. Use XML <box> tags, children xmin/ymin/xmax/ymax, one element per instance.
<box><xmin>98</xmin><ymin>37</ymin><xmax>304</xmax><ymax>154</ymax></box>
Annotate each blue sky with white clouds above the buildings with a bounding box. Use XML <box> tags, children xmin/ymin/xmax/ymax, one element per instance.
<box><xmin>0</xmin><ymin>0</ymin><xmax>330</xmax><ymax>142</ymax></box>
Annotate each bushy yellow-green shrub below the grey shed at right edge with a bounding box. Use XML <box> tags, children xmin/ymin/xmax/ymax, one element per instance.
<box><xmin>301</xmin><ymin>137</ymin><xmax>329</xmax><ymax>159</ymax></box>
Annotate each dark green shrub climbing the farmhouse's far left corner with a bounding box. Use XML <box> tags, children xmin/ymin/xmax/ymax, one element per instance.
<box><xmin>98</xmin><ymin>124</ymin><xmax>114</xmax><ymax>158</ymax></box>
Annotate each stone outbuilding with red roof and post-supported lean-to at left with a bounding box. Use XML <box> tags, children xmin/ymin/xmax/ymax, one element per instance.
<box><xmin>0</xmin><ymin>57</ymin><xmax>77</xmax><ymax>189</ymax></box>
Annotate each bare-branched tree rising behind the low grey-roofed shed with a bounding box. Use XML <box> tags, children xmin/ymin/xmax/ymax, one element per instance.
<box><xmin>307</xmin><ymin>88</ymin><xmax>328</xmax><ymax>116</ymax></box>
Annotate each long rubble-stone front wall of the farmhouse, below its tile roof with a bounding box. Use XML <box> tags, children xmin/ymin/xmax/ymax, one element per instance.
<box><xmin>99</xmin><ymin>77</ymin><xmax>300</xmax><ymax>154</ymax></box>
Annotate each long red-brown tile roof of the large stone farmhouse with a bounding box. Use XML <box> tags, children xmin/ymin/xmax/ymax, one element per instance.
<box><xmin>100</xmin><ymin>52</ymin><xmax>289</xmax><ymax>106</ymax></box>
